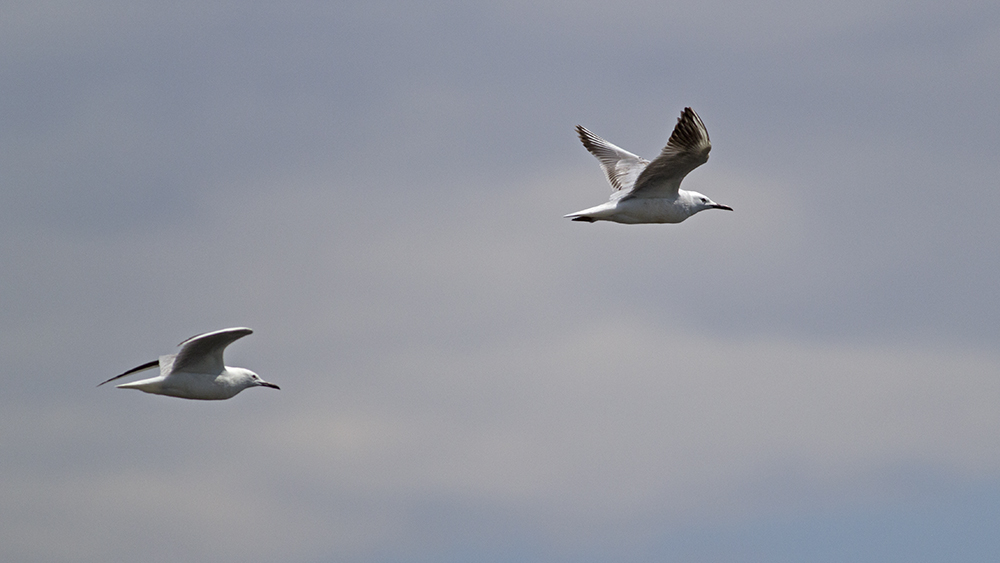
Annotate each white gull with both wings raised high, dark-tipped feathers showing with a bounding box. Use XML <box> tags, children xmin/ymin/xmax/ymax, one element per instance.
<box><xmin>565</xmin><ymin>108</ymin><xmax>733</xmax><ymax>224</ymax></box>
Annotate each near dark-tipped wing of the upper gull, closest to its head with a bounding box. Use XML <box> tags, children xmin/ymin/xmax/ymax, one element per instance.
<box><xmin>625</xmin><ymin>108</ymin><xmax>712</xmax><ymax>197</ymax></box>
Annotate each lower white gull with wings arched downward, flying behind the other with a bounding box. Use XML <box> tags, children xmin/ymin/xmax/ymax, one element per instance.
<box><xmin>97</xmin><ymin>327</ymin><xmax>281</xmax><ymax>401</ymax></box>
